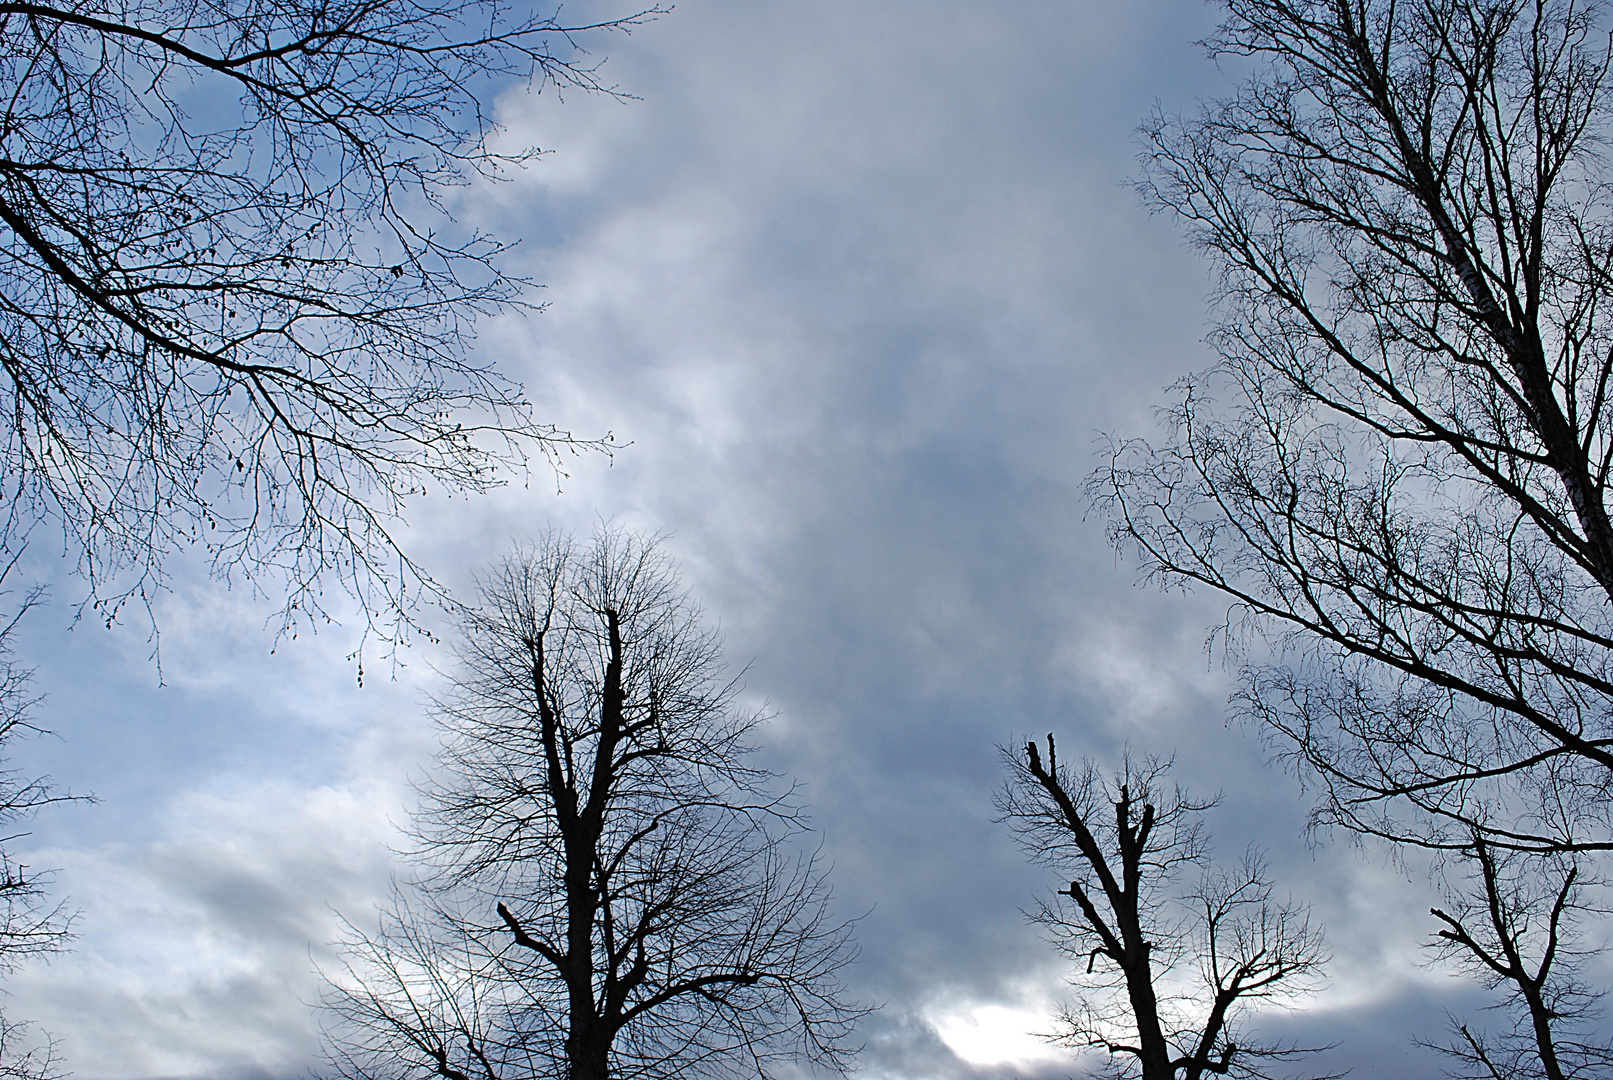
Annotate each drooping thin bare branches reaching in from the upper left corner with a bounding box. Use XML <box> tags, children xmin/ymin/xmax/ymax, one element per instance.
<box><xmin>0</xmin><ymin>0</ymin><xmax>655</xmax><ymax>644</ymax></box>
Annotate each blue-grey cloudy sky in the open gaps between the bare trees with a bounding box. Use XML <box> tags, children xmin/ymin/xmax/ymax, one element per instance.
<box><xmin>6</xmin><ymin>0</ymin><xmax>1522</xmax><ymax>1080</ymax></box>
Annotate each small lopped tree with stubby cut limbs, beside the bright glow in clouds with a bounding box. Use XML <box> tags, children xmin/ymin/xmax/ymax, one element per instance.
<box><xmin>997</xmin><ymin>735</ymin><xmax>1326</xmax><ymax>1080</ymax></box>
